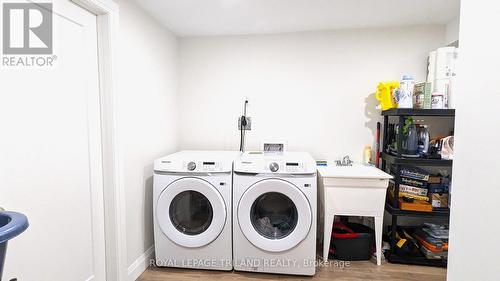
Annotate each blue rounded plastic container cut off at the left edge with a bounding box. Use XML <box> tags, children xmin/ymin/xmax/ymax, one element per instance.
<box><xmin>0</xmin><ymin>212</ymin><xmax>29</xmax><ymax>280</ymax></box>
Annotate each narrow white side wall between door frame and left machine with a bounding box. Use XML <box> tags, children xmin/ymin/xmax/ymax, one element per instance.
<box><xmin>116</xmin><ymin>0</ymin><xmax>178</xmax><ymax>280</ymax></box>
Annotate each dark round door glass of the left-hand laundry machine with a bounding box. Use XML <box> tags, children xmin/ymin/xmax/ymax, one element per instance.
<box><xmin>169</xmin><ymin>190</ymin><xmax>213</xmax><ymax>235</ymax></box>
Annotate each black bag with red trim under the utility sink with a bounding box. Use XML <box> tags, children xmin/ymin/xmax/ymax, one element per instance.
<box><xmin>330</xmin><ymin>222</ymin><xmax>375</xmax><ymax>261</ymax></box>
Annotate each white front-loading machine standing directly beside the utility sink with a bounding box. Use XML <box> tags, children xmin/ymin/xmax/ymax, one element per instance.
<box><xmin>233</xmin><ymin>152</ymin><xmax>317</xmax><ymax>275</ymax></box>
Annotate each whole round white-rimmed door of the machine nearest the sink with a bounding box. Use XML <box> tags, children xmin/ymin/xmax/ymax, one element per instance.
<box><xmin>237</xmin><ymin>179</ymin><xmax>312</xmax><ymax>252</ymax></box>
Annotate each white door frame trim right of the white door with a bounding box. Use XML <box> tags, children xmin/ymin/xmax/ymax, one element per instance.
<box><xmin>70</xmin><ymin>0</ymin><xmax>128</xmax><ymax>281</ymax></box>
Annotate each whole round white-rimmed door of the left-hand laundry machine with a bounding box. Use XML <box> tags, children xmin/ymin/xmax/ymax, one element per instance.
<box><xmin>155</xmin><ymin>178</ymin><xmax>227</xmax><ymax>248</ymax></box>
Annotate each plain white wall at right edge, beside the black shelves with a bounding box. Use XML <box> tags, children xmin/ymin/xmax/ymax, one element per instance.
<box><xmin>448</xmin><ymin>0</ymin><xmax>500</xmax><ymax>281</ymax></box>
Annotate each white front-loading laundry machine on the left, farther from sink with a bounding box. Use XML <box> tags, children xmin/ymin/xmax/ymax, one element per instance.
<box><xmin>153</xmin><ymin>151</ymin><xmax>240</xmax><ymax>270</ymax></box>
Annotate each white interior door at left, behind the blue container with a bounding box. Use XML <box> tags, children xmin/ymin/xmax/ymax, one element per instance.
<box><xmin>0</xmin><ymin>0</ymin><xmax>105</xmax><ymax>281</ymax></box>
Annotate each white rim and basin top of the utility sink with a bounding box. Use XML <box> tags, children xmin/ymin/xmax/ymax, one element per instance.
<box><xmin>318</xmin><ymin>164</ymin><xmax>392</xmax><ymax>179</ymax></box>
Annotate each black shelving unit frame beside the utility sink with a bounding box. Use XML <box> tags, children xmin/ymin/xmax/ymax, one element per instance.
<box><xmin>381</xmin><ymin>108</ymin><xmax>455</xmax><ymax>267</ymax></box>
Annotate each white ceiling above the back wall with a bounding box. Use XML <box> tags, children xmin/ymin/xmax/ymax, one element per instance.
<box><xmin>133</xmin><ymin>0</ymin><xmax>460</xmax><ymax>37</ymax></box>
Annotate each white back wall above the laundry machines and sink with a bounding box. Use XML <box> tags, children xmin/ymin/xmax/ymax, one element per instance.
<box><xmin>179</xmin><ymin>26</ymin><xmax>445</xmax><ymax>161</ymax></box>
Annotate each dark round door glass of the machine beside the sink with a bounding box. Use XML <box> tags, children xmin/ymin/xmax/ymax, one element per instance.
<box><xmin>250</xmin><ymin>192</ymin><xmax>298</xmax><ymax>239</ymax></box>
